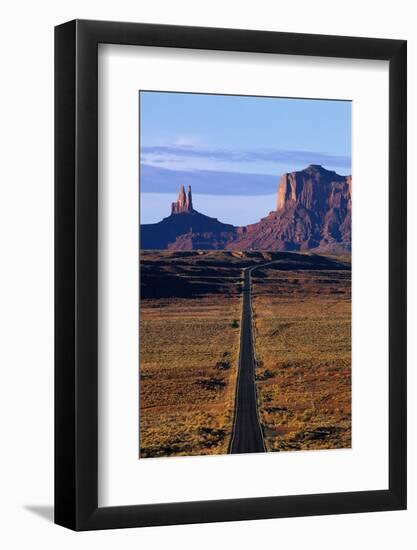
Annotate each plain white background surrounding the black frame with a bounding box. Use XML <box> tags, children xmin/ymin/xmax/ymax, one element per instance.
<box><xmin>0</xmin><ymin>0</ymin><xmax>417</xmax><ymax>550</ymax></box>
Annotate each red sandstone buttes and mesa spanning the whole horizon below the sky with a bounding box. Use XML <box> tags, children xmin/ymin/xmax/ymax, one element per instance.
<box><xmin>141</xmin><ymin>164</ymin><xmax>352</xmax><ymax>253</ymax></box>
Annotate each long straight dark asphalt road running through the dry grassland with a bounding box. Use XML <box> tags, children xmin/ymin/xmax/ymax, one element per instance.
<box><xmin>229</xmin><ymin>262</ymin><xmax>270</xmax><ymax>454</ymax></box>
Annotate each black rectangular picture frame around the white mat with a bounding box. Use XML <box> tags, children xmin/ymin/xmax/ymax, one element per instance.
<box><xmin>55</xmin><ymin>20</ymin><xmax>407</xmax><ymax>531</ymax></box>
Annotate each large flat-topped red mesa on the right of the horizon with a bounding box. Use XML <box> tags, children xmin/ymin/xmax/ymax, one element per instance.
<box><xmin>227</xmin><ymin>165</ymin><xmax>352</xmax><ymax>252</ymax></box>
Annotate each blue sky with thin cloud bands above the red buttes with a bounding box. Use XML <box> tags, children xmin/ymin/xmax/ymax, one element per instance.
<box><xmin>139</xmin><ymin>92</ymin><xmax>351</xmax><ymax>225</ymax></box>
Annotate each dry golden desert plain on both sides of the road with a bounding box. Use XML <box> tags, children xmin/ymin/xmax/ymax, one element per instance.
<box><xmin>139</xmin><ymin>251</ymin><xmax>351</xmax><ymax>458</ymax></box>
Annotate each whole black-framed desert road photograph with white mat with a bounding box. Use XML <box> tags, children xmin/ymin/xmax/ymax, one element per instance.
<box><xmin>55</xmin><ymin>20</ymin><xmax>406</xmax><ymax>530</ymax></box>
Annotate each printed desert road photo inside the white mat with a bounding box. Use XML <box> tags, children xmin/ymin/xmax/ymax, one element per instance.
<box><xmin>139</xmin><ymin>92</ymin><xmax>352</xmax><ymax>459</ymax></box>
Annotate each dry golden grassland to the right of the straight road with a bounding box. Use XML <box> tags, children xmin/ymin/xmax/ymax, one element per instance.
<box><xmin>252</xmin><ymin>255</ymin><xmax>351</xmax><ymax>451</ymax></box>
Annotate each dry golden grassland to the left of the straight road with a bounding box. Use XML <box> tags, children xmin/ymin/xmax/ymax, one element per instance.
<box><xmin>140</xmin><ymin>252</ymin><xmax>245</xmax><ymax>458</ymax></box>
